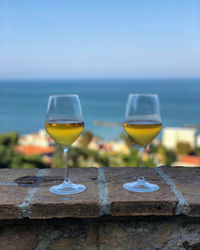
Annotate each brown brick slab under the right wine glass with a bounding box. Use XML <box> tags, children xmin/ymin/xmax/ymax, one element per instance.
<box><xmin>104</xmin><ymin>168</ymin><xmax>177</xmax><ymax>216</ymax></box>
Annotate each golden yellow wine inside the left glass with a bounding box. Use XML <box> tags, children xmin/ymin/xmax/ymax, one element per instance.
<box><xmin>45</xmin><ymin>120</ymin><xmax>84</xmax><ymax>147</ymax></box>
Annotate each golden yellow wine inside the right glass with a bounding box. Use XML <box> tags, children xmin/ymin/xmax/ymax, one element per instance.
<box><xmin>124</xmin><ymin>121</ymin><xmax>162</xmax><ymax>147</ymax></box>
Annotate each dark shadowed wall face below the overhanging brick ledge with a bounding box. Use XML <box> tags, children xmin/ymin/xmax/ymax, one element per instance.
<box><xmin>0</xmin><ymin>216</ymin><xmax>200</xmax><ymax>250</ymax></box>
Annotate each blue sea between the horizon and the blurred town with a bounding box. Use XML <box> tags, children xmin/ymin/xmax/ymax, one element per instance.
<box><xmin>0</xmin><ymin>79</ymin><xmax>200</xmax><ymax>140</ymax></box>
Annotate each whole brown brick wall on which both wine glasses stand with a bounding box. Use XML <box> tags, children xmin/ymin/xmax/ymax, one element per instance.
<box><xmin>0</xmin><ymin>167</ymin><xmax>200</xmax><ymax>250</ymax></box>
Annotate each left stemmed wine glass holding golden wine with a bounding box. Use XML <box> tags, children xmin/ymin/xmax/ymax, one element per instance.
<box><xmin>45</xmin><ymin>95</ymin><xmax>86</xmax><ymax>195</ymax></box>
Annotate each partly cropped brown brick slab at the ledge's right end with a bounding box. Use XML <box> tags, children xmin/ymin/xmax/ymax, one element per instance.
<box><xmin>162</xmin><ymin>167</ymin><xmax>200</xmax><ymax>217</ymax></box>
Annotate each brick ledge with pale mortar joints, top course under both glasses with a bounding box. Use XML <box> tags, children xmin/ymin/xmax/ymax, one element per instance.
<box><xmin>0</xmin><ymin>167</ymin><xmax>200</xmax><ymax>219</ymax></box>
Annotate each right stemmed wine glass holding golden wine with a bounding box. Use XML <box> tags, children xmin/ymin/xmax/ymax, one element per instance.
<box><xmin>123</xmin><ymin>94</ymin><xmax>162</xmax><ymax>193</ymax></box>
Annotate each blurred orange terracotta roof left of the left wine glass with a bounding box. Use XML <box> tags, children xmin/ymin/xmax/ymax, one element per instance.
<box><xmin>15</xmin><ymin>145</ymin><xmax>55</xmax><ymax>155</ymax></box>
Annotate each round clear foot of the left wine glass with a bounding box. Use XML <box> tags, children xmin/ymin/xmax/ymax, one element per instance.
<box><xmin>49</xmin><ymin>181</ymin><xmax>86</xmax><ymax>195</ymax></box>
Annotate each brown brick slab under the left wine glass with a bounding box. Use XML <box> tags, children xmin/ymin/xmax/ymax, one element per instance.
<box><xmin>30</xmin><ymin>168</ymin><xmax>100</xmax><ymax>218</ymax></box>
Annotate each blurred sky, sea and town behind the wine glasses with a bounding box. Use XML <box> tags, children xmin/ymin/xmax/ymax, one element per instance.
<box><xmin>0</xmin><ymin>0</ymin><xmax>200</xmax><ymax>168</ymax></box>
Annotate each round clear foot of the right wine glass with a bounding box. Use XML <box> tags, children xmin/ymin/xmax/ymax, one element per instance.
<box><xmin>123</xmin><ymin>177</ymin><xmax>159</xmax><ymax>193</ymax></box>
